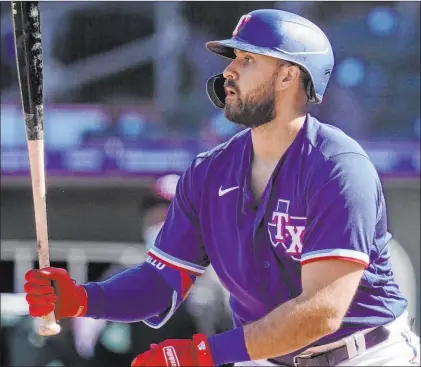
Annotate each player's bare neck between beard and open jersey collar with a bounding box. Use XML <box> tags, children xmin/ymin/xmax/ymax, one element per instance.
<box><xmin>251</xmin><ymin>112</ymin><xmax>306</xmax><ymax>163</ymax></box>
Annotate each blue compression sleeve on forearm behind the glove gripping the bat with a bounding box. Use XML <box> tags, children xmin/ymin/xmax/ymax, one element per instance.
<box><xmin>83</xmin><ymin>263</ymin><xmax>173</xmax><ymax>322</ymax></box>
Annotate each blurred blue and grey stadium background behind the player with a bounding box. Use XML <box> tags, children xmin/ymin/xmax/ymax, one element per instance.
<box><xmin>0</xmin><ymin>1</ymin><xmax>421</xmax><ymax>366</ymax></box>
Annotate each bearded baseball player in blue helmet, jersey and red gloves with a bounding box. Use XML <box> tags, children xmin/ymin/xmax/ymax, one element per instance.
<box><xmin>25</xmin><ymin>9</ymin><xmax>420</xmax><ymax>366</ymax></box>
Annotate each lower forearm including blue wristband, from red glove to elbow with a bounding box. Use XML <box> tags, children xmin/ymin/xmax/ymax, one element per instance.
<box><xmin>209</xmin><ymin>291</ymin><xmax>343</xmax><ymax>366</ymax></box>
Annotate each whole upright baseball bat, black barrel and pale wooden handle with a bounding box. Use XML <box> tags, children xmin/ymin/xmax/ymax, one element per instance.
<box><xmin>12</xmin><ymin>1</ymin><xmax>60</xmax><ymax>336</ymax></box>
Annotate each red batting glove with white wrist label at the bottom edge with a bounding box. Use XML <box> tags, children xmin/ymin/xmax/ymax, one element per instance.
<box><xmin>131</xmin><ymin>334</ymin><xmax>214</xmax><ymax>367</ymax></box>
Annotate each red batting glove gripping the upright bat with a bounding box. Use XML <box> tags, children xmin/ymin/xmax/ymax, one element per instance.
<box><xmin>24</xmin><ymin>267</ymin><xmax>88</xmax><ymax>320</ymax></box>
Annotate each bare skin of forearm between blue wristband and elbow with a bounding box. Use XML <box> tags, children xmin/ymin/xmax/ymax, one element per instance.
<box><xmin>244</xmin><ymin>292</ymin><xmax>341</xmax><ymax>360</ymax></box>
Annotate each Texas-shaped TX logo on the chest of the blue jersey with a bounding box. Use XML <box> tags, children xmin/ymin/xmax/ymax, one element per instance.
<box><xmin>268</xmin><ymin>199</ymin><xmax>307</xmax><ymax>261</ymax></box>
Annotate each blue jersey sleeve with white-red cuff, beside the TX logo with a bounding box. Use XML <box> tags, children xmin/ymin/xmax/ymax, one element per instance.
<box><xmin>301</xmin><ymin>153</ymin><xmax>384</xmax><ymax>268</ymax></box>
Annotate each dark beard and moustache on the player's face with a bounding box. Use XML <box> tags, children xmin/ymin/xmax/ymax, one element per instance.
<box><xmin>224</xmin><ymin>74</ymin><xmax>277</xmax><ymax>128</ymax></box>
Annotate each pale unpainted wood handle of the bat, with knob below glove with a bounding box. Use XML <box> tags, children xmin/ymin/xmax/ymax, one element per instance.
<box><xmin>27</xmin><ymin>139</ymin><xmax>60</xmax><ymax>336</ymax></box>
